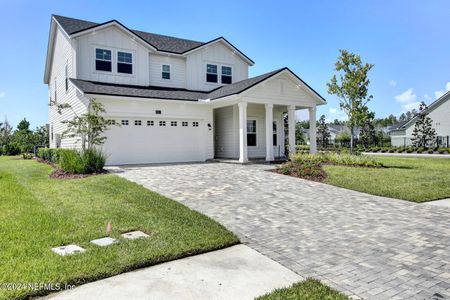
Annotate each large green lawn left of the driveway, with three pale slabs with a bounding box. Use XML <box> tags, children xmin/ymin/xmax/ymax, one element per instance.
<box><xmin>0</xmin><ymin>157</ymin><xmax>239</xmax><ymax>299</ymax></box>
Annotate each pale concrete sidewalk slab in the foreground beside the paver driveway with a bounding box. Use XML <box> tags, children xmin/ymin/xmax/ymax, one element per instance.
<box><xmin>45</xmin><ymin>245</ymin><xmax>303</xmax><ymax>300</ymax></box>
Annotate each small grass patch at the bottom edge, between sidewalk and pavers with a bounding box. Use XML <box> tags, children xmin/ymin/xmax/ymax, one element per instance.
<box><xmin>256</xmin><ymin>279</ymin><xmax>348</xmax><ymax>300</ymax></box>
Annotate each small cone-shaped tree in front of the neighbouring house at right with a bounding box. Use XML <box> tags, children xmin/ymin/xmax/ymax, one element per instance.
<box><xmin>411</xmin><ymin>102</ymin><xmax>436</xmax><ymax>147</ymax></box>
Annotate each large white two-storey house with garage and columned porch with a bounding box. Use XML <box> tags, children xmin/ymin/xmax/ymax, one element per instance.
<box><xmin>44</xmin><ymin>15</ymin><xmax>326</xmax><ymax>165</ymax></box>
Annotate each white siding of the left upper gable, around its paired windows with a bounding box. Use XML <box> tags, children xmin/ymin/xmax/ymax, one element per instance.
<box><xmin>77</xmin><ymin>27</ymin><xmax>149</xmax><ymax>85</ymax></box>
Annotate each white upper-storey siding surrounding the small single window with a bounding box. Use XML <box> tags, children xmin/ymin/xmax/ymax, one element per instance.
<box><xmin>149</xmin><ymin>54</ymin><xmax>186</xmax><ymax>88</ymax></box>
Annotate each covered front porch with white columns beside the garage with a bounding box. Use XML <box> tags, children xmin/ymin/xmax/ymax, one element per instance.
<box><xmin>213</xmin><ymin>101</ymin><xmax>316</xmax><ymax>163</ymax></box>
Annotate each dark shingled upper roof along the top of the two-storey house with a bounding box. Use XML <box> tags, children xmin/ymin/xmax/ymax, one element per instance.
<box><xmin>53</xmin><ymin>15</ymin><xmax>254</xmax><ymax>64</ymax></box>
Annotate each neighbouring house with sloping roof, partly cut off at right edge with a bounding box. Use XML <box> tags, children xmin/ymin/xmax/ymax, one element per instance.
<box><xmin>389</xmin><ymin>92</ymin><xmax>450</xmax><ymax>147</ymax></box>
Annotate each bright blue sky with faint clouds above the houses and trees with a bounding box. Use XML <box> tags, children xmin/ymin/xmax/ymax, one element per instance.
<box><xmin>0</xmin><ymin>0</ymin><xmax>450</xmax><ymax>127</ymax></box>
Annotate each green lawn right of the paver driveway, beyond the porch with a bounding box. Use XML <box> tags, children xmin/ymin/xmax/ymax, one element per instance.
<box><xmin>324</xmin><ymin>157</ymin><xmax>450</xmax><ymax>202</ymax></box>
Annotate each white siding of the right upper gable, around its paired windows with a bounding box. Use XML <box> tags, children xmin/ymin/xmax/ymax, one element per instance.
<box><xmin>186</xmin><ymin>42</ymin><xmax>248</xmax><ymax>91</ymax></box>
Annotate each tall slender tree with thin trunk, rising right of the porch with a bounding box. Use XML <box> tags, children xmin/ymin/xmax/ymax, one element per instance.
<box><xmin>327</xmin><ymin>50</ymin><xmax>374</xmax><ymax>153</ymax></box>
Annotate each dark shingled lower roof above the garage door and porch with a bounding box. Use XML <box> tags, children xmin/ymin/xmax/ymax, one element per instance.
<box><xmin>70</xmin><ymin>68</ymin><xmax>326</xmax><ymax>103</ymax></box>
